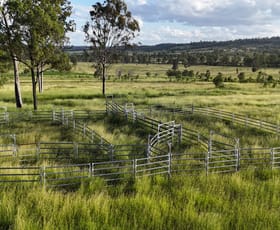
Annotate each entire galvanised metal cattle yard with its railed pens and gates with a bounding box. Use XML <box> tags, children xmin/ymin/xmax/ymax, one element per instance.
<box><xmin>0</xmin><ymin>97</ymin><xmax>280</xmax><ymax>187</ymax></box>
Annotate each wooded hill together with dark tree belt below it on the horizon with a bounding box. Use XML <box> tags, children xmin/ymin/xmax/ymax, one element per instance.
<box><xmin>67</xmin><ymin>37</ymin><xmax>280</xmax><ymax>69</ymax></box>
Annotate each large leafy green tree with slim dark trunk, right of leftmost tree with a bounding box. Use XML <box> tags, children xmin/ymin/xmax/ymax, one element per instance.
<box><xmin>7</xmin><ymin>0</ymin><xmax>72</xmax><ymax>110</ymax></box>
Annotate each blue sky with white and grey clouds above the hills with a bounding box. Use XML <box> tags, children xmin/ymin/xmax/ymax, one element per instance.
<box><xmin>68</xmin><ymin>0</ymin><xmax>280</xmax><ymax>45</ymax></box>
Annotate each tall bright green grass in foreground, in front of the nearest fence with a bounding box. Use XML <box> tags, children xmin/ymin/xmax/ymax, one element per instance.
<box><xmin>0</xmin><ymin>170</ymin><xmax>280</xmax><ymax>229</ymax></box>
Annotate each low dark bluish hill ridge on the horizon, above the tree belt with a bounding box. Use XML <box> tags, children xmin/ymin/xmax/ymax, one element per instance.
<box><xmin>66</xmin><ymin>37</ymin><xmax>280</xmax><ymax>52</ymax></box>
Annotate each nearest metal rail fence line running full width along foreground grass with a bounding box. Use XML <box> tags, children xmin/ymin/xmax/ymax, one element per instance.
<box><xmin>0</xmin><ymin>148</ymin><xmax>280</xmax><ymax>187</ymax></box>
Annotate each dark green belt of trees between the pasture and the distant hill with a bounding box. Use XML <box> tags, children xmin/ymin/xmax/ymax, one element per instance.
<box><xmin>70</xmin><ymin>49</ymin><xmax>280</xmax><ymax>70</ymax></box>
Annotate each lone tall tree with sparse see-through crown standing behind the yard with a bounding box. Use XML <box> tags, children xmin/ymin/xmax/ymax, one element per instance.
<box><xmin>84</xmin><ymin>0</ymin><xmax>140</xmax><ymax>95</ymax></box>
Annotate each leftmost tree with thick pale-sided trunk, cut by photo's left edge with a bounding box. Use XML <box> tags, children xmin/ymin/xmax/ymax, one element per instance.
<box><xmin>0</xmin><ymin>0</ymin><xmax>22</xmax><ymax>108</ymax></box>
